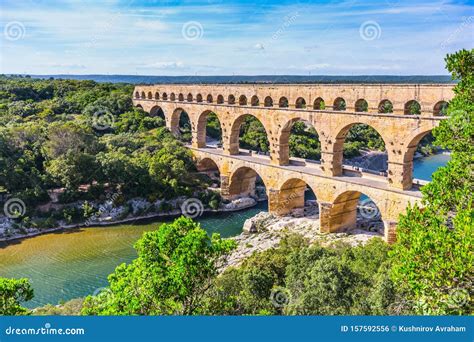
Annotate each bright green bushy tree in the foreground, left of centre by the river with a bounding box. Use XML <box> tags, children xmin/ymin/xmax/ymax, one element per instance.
<box><xmin>82</xmin><ymin>217</ymin><xmax>235</xmax><ymax>315</ymax></box>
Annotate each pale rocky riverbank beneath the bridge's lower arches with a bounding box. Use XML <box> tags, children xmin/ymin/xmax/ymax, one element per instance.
<box><xmin>225</xmin><ymin>209</ymin><xmax>383</xmax><ymax>268</ymax></box>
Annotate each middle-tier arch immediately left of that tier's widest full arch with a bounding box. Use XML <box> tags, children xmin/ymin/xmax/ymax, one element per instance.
<box><xmin>277</xmin><ymin>117</ymin><xmax>321</xmax><ymax>165</ymax></box>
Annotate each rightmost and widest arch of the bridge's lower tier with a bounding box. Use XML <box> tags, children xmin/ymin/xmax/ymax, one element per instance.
<box><xmin>320</xmin><ymin>190</ymin><xmax>383</xmax><ymax>235</ymax></box>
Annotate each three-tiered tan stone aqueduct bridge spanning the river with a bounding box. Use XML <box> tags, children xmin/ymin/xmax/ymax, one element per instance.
<box><xmin>133</xmin><ymin>84</ymin><xmax>454</xmax><ymax>242</ymax></box>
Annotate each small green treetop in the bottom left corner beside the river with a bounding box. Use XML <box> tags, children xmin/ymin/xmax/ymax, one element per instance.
<box><xmin>0</xmin><ymin>278</ymin><xmax>33</xmax><ymax>316</ymax></box>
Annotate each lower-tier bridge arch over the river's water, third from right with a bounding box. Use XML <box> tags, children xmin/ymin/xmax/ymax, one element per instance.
<box><xmin>226</xmin><ymin>166</ymin><xmax>268</xmax><ymax>199</ymax></box>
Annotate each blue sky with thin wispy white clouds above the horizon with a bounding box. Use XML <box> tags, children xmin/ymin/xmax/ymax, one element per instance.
<box><xmin>0</xmin><ymin>0</ymin><xmax>474</xmax><ymax>75</ymax></box>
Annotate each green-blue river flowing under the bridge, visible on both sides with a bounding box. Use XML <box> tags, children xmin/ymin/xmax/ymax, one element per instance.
<box><xmin>0</xmin><ymin>154</ymin><xmax>449</xmax><ymax>308</ymax></box>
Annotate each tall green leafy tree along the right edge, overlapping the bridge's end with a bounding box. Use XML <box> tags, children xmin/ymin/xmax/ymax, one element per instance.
<box><xmin>391</xmin><ymin>50</ymin><xmax>474</xmax><ymax>314</ymax></box>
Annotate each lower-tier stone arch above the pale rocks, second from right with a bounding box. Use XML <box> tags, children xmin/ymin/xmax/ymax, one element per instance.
<box><xmin>269</xmin><ymin>178</ymin><xmax>316</xmax><ymax>216</ymax></box>
